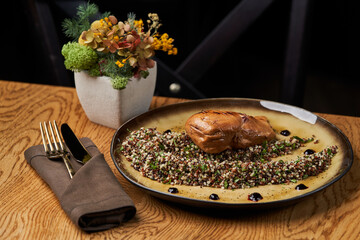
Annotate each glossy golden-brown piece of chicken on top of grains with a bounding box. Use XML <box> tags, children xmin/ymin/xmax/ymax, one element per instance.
<box><xmin>185</xmin><ymin>110</ymin><xmax>275</xmax><ymax>153</ymax></box>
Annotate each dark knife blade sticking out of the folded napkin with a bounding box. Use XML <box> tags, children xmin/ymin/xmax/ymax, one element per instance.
<box><xmin>61</xmin><ymin>123</ymin><xmax>91</xmax><ymax>164</ymax></box>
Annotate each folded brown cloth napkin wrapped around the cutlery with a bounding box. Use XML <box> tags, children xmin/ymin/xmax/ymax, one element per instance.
<box><xmin>24</xmin><ymin>138</ymin><xmax>136</xmax><ymax>232</ymax></box>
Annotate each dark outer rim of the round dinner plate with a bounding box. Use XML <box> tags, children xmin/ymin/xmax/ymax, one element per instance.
<box><xmin>110</xmin><ymin>98</ymin><xmax>354</xmax><ymax>208</ymax></box>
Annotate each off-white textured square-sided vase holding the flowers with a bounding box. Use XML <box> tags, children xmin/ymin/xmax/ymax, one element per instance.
<box><xmin>75</xmin><ymin>62</ymin><xmax>157</xmax><ymax>129</ymax></box>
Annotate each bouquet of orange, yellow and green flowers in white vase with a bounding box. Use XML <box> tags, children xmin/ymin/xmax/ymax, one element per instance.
<box><xmin>61</xmin><ymin>3</ymin><xmax>177</xmax><ymax>89</ymax></box>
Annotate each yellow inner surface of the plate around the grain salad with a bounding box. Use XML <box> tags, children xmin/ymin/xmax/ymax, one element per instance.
<box><xmin>116</xmin><ymin>107</ymin><xmax>344</xmax><ymax>203</ymax></box>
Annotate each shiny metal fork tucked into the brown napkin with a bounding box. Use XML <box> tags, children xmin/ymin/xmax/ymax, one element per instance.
<box><xmin>40</xmin><ymin>120</ymin><xmax>75</xmax><ymax>178</ymax></box>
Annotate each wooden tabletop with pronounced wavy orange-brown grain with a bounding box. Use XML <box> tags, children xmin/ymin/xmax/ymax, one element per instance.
<box><xmin>0</xmin><ymin>81</ymin><xmax>360</xmax><ymax>239</ymax></box>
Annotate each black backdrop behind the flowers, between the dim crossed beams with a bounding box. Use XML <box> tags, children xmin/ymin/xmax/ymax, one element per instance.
<box><xmin>0</xmin><ymin>0</ymin><xmax>360</xmax><ymax>116</ymax></box>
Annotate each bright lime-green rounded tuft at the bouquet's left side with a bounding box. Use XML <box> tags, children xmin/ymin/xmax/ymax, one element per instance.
<box><xmin>61</xmin><ymin>42</ymin><xmax>98</xmax><ymax>71</ymax></box>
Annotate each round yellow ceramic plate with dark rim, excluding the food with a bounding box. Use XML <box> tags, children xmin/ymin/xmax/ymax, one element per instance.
<box><xmin>111</xmin><ymin>98</ymin><xmax>353</xmax><ymax>208</ymax></box>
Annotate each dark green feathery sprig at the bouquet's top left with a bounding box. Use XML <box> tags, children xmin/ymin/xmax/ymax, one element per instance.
<box><xmin>62</xmin><ymin>2</ymin><xmax>99</xmax><ymax>41</ymax></box>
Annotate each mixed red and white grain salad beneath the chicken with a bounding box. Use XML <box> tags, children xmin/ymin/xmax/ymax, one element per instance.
<box><xmin>117</xmin><ymin>128</ymin><xmax>338</xmax><ymax>189</ymax></box>
